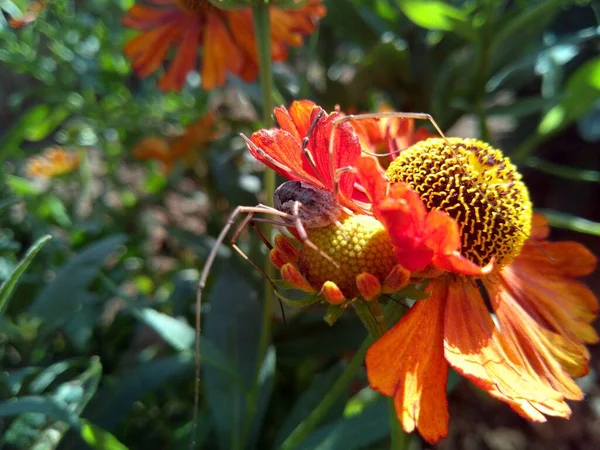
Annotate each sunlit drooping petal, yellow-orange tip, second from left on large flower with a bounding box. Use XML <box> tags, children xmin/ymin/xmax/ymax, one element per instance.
<box><xmin>446</xmin><ymin>278</ymin><xmax>571</xmax><ymax>422</ymax></box>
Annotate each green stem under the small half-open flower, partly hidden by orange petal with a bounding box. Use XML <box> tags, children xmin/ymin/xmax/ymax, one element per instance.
<box><xmin>352</xmin><ymin>300</ymin><xmax>410</xmax><ymax>450</ymax></box>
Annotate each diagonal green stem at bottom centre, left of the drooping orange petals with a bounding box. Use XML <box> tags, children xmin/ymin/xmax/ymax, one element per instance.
<box><xmin>280</xmin><ymin>336</ymin><xmax>372</xmax><ymax>450</ymax></box>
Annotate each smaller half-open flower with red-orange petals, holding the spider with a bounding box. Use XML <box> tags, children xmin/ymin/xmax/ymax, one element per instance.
<box><xmin>247</xmin><ymin>100</ymin><xmax>482</xmax><ymax>305</ymax></box>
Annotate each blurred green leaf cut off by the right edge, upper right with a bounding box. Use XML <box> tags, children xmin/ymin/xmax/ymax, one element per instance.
<box><xmin>537</xmin><ymin>56</ymin><xmax>600</xmax><ymax>137</ymax></box>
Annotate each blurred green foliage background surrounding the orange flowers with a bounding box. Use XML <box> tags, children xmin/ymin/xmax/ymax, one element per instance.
<box><xmin>0</xmin><ymin>0</ymin><xmax>600</xmax><ymax>450</ymax></box>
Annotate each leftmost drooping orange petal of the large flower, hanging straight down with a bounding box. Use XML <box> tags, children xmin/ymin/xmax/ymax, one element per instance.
<box><xmin>366</xmin><ymin>282</ymin><xmax>449</xmax><ymax>443</ymax></box>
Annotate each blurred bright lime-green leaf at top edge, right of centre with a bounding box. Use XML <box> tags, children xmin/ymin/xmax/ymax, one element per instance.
<box><xmin>399</xmin><ymin>0</ymin><xmax>476</xmax><ymax>39</ymax></box>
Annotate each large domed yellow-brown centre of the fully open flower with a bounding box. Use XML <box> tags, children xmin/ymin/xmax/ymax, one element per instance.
<box><xmin>386</xmin><ymin>138</ymin><xmax>532</xmax><ymax>268</ymax></box>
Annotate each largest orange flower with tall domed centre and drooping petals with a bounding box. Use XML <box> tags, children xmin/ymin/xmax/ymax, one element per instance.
<box><xmin>359</xmin><ymin>139</ymin><xmax>598</xmax><ymax>443</ymax></box>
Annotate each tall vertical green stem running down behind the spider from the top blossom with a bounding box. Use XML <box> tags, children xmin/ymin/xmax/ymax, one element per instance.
<box><xmin>239</xmin><ymin>0</ymin><xmax>275</xmax><ymax>448</ymax></box>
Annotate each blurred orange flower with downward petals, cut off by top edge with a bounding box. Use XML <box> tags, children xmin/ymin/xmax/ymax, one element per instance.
<box><xmin>124</xmin><ymin>0</ymin><xmax>325</xmax><ymax>91</ymax></box>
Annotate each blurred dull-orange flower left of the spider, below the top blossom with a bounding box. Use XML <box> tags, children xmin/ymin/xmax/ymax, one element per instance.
<box><xmin>133</xmin><ymin>113</ymin><xmax>218</xmax><ymax>173</ymax></box>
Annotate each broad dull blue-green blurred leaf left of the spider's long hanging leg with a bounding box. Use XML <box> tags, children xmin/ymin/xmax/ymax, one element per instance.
<box><xmin>29</xmin><ymin>235</ymin><xmax>126</xmax><ymax>335</ymax></box>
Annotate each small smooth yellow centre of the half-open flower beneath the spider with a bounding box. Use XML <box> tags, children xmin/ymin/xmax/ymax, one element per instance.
<box><xmin>299</xmin><ymin>215</ymin><xmax>396</xmax><ymax>298</ymax></box>
